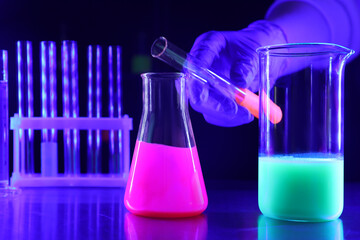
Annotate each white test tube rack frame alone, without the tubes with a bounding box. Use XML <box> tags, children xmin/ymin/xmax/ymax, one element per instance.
<box><xmin>10</xmin><ymin>115</ymin><xmax>132</xmax><ymax>187</ymax></box>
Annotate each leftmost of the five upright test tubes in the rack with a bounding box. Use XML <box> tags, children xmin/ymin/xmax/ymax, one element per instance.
<box><xmin>16</xmin><ymin>41</ymin><xmax>34</xmax><ymax>174</ymax></box>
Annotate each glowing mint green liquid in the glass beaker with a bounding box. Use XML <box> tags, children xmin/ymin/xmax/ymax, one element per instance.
<box><xmin>259</xmin><ymin>156</ymin><xmax>344</xmax><ymax>221</ymax></box>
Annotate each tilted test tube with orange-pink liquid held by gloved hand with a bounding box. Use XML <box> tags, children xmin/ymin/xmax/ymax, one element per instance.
<box><xmin>151</xmin><ymin>37</ymin><xmax>282</xmax><ymax>123</ymax></box>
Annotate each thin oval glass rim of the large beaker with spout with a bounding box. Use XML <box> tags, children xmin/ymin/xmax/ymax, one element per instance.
<box><xmin>256</xmin><ymin>43</ymin><xmax>355</xmax><ymax>57</ymax></box>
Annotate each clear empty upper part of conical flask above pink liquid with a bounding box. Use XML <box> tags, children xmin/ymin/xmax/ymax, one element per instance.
<box><xmin>138</xmin><ymin>73</ymin><xmax>195</xmax><ymax>147</ymax></box>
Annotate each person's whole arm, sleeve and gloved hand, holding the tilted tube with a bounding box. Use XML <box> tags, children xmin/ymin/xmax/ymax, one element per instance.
<box><xmin>188</xmin><ymin>0</ymin><xmax>360</xmax><ymax>127</ymax></box>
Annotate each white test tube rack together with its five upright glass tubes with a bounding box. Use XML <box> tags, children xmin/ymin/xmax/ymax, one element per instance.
<box><xmin>10</xmin><ymin>40</ymin><xmax>132</xmax><ymax>187</ymax></box>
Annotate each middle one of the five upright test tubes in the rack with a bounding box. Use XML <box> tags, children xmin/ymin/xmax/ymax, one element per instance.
<box><xmin>61</xmin><ymin>41</ymin><xmax>80</xmax><ymax>174</ymax></box>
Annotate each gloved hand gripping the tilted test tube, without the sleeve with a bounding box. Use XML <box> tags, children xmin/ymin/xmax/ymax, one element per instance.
<box><xmin>188</xmin><ymin>20</ymin><xmax>286</xmax><ymax>127</ymax></box>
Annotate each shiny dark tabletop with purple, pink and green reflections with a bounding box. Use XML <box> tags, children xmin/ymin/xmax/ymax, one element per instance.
<box><xmin>0</xmin><ymin>181</ymin><xmax>360</xmax><ymax>240</ymax></box>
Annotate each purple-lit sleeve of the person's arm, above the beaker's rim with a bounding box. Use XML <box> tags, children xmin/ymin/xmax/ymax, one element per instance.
<box><xmin>265</xmin><ymin>0</ymin><xmax>360</xmax><ymax>56</ymax></box>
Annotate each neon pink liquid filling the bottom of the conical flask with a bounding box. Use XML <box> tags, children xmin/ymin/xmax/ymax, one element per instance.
<box><xmin>124</xmin><ymin>141</ymin><xmax>208</xmax><ymax>217</ymax></box>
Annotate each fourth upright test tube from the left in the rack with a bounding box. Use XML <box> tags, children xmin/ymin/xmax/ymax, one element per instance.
<box><xmin>87</xmin><ymin>45</ymin><xmax>102</xmax><ymax>173</ymax></box>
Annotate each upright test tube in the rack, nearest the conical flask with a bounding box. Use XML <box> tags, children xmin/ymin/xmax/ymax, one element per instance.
<box><xmin>108</xmin><ymin>46</ymin><xmax>124</xmax><ymax>174</ymax></box>
